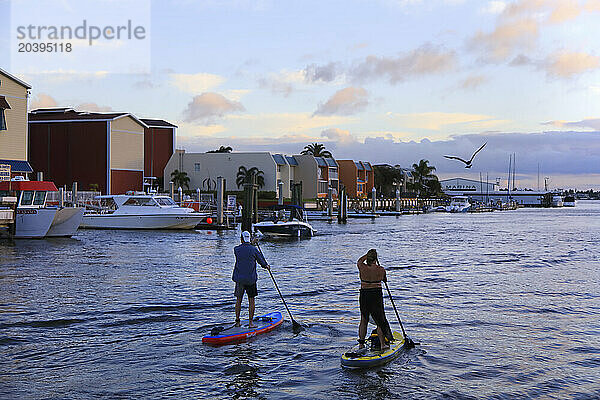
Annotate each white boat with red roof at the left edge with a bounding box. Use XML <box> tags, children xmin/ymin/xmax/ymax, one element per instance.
<box><xmin>0</xmin><ymin>177</ymin><xmax>58</xmax><ymax>239</ymax></box>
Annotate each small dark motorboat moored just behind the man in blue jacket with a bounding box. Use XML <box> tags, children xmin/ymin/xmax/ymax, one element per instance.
<box><xmin>253</xmin><ymin>205</ymin><xmax>316</xmax><ymax>238</ymax></box>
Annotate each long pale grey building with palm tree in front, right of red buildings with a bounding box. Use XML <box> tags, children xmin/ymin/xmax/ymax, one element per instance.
<box><xmin>164</xmin><ymin>150</ymin><xmax>298</xmax><ymax>198</ymax></box>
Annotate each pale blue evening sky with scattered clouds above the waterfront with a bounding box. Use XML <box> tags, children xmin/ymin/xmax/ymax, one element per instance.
<box><xmin>0</xmin><ymin>0</ymin><xmax>600</xmax><ymax>189</ymax></box>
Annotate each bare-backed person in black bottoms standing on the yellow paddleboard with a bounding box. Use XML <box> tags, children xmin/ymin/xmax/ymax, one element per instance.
<box><xmin>356</xmin><ymin>249</ymin><xmax>393</xmax><ymax>350</ymax></box>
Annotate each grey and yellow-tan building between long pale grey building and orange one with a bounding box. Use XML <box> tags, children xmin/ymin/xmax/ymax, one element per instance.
<box><xmin>294</xmin><ymin>154</ymin><xmax>340</xmax><ymax>199</ymax></box>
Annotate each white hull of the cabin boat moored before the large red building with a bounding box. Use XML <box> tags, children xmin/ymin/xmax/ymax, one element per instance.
<box><xmin>80</xmin><ymin>214</ymin><xmax>205</xmax><ymax>229</ymax></box>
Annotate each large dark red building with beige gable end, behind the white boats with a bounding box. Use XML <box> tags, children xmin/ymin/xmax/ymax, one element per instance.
<box><xmin>29</xmin><ymin>108</ymin><xmax>148</xmax><ymax>194</ymax></box>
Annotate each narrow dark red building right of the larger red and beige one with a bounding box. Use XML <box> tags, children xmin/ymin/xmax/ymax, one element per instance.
<box><xmin>141</xmin><ymin>118</ymin><xmax>177</xmax><ymax>177</ymax></box>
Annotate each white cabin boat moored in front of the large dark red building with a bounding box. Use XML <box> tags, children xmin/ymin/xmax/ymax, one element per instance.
<box><xmin>81</xmin><ymin>193</ymin><xmax>210</xmax><ymax>229</ymax></box>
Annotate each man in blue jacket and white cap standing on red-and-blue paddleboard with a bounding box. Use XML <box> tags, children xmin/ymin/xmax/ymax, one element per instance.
<box><xmin>231</xmin><ymin>231</ymin><xmax>270</xmax><ymax>328</ymax></box>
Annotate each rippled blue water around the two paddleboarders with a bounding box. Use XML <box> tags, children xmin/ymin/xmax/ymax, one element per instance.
<box><xmin>0</xmin><ymin>202</ymin><xmax>600</xmax><ymax>399</ymax></box>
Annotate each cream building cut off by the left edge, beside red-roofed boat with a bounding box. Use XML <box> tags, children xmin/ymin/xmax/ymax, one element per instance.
<box><xmin>0</xmin><ymin>69</ymin><xmax>33</xmax><ymax>176</ymax></box>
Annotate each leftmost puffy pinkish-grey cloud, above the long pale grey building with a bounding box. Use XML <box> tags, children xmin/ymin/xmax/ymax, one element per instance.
<box><xmin>183</xmin><ymin>92</ymin><xmax>246</xmax><ymax>125</ymax></box>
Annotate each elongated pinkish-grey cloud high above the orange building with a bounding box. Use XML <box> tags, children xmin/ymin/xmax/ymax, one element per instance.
<box><xmin>348</xmin><ymin>44</ymin><xmax>456</xmax><ymax>84</ymax></box>
